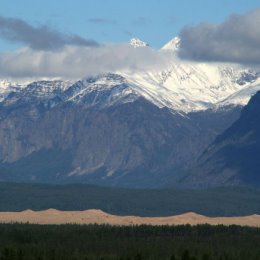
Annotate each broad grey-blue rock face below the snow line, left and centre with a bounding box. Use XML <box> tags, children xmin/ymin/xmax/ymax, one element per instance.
<box><xmin>0</xmin><ymin>90</ymin><xmax>240</xmax><ymax>187</ymax></box>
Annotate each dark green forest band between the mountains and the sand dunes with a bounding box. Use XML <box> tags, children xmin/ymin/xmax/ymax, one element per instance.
<box><xmin>0</xmin><ymin>183</ymin><xmax>260</xmax><ymax>216</ymax></box>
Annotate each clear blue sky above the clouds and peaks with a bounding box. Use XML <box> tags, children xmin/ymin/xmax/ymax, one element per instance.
<box><xmin>0</xmin><ymin>0</ymin><xmax>260</xmax><ymax>50</ymax></box>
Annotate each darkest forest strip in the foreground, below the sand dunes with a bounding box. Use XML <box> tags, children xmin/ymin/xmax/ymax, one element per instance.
<box><xmin>0</xmin><ymin>224</ymin><xmax>260</xmax><ymax>260</ymax></box>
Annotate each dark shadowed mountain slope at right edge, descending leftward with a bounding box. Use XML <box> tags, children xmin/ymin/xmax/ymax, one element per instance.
<box><xmin>183</xmin><ymin>92</ymin><xmax>260</xmax><ymax>187</ymax></box>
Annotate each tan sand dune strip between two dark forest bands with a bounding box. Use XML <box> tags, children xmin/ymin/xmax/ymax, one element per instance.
<box><xmin>0</xmin><ymin>209</ymin><xmax>260</xmax><ymax>227</ymax></box>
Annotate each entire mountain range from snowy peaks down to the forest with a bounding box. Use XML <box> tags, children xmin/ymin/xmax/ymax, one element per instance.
<box><xmin>0</xmin><ymin>38</ymin><xmax>260</xmax><ymax>188</ymax></box>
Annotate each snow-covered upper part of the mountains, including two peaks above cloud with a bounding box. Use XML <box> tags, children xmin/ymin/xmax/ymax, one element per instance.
<box><xmin>0</xmin><ymin>37</ymin><xmax>260</xmax><ymax>113</ymax></box>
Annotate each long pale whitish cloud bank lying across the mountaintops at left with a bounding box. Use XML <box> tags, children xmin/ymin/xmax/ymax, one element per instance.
<box><xmin>0</xmin><ymin>44</ymin><xmax>171</xmax><ymax>79</ymax></box>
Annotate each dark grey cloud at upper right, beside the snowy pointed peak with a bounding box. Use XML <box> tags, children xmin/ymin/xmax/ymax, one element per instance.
<box><xmin>180</xmin><ymin>8</ymin><xmax>260</xmax><ymax>65</ymax></box>
